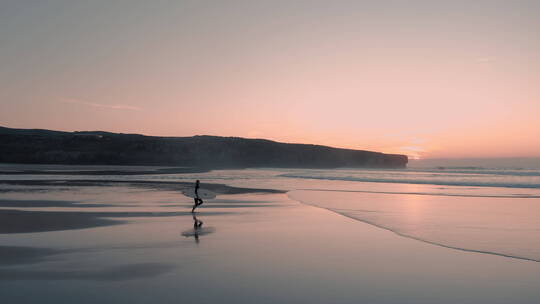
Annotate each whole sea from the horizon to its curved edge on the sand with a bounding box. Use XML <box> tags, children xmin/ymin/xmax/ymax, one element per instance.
<box><xmin>0</xmin><ymin>165</ymin><xmax>540</xmax><ymax>262</ymax></box>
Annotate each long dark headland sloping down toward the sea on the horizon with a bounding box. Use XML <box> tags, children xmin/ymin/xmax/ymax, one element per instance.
<box><xmin>0</xmin><ymin>127</ymin><xmax>408</xmax><ymax>169</ymax></box>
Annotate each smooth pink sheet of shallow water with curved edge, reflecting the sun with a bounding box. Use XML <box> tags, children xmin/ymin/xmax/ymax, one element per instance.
<box><xmin>289</xmin><ymin>190</ymin><xmax>540</xmax><ymax>262</ymax></box>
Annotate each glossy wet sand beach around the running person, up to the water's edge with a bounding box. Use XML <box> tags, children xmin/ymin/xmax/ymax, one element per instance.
<box><xmin>0</xmin><ymin>173</ymin><xmax>540</xmax><ymax>303</ymax></box>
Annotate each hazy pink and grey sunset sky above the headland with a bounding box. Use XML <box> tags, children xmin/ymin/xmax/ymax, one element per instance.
<box><xmin>0</xmin><ymin>0</ymin><xmax>540</xmax><ymax>158</ymax></box>
